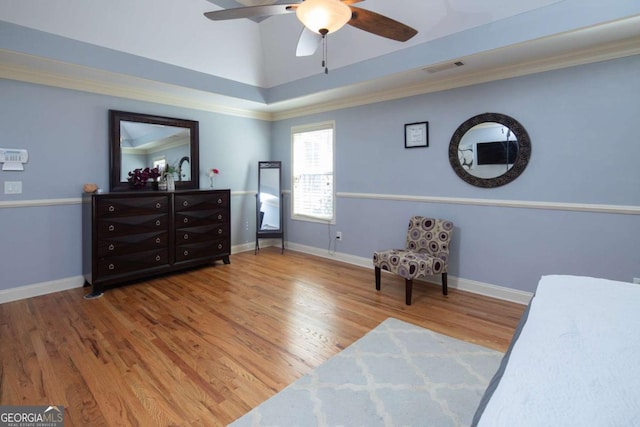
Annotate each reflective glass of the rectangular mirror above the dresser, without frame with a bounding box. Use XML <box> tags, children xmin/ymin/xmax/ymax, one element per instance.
<box><xmin>120</xmin><ymin>120</ymin><xmax>191</xmax><ymax>182</ymax></box>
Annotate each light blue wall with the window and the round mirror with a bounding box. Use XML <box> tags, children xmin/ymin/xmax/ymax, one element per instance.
<box><xmin>273</xmin><ymin>56</ymin><xmax>640</xmax><ymax>292</ymax></box>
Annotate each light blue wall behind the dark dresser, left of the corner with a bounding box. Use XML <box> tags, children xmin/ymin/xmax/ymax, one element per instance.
<box><xmin>0</xmin><ymin>79</ymin><xmax>271</xmax><ymax>290</ymax></box>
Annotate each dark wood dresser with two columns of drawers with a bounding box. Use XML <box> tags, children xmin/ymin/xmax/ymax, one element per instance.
<box><xmin>82</xmin><ymin>190</ymin><xmax>231</xmax><ymax>296</ymax></box>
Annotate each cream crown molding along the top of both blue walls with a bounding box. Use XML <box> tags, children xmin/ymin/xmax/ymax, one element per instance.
<box><xmin>0</xmin><ymin>30</ymin><xmax>640</xmax><ymax>121</ymax></box>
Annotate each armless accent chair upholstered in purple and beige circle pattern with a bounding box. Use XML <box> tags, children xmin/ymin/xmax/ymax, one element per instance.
<box><xmin>373</xmin><ymin>216</ymin><xmax>453</xmax><ymax>305</ymax></box>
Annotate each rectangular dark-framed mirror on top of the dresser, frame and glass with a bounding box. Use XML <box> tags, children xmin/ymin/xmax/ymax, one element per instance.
<box><xmin>109</xmin><ymin>110</ymin><xmax>200</xmax><ymax>191</ymax></box>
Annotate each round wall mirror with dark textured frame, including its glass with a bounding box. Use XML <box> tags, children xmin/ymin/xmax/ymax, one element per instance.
<box><xmin>449</xmin><ymin>113</ymin><xmax>531</xmax><ymax>188</ymax></box>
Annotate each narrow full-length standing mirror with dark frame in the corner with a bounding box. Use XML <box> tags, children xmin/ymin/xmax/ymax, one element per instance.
<box><xmin>255</xmin><ymin>162</ymin><xmax>284</xmax><ymax>253</ymax></box>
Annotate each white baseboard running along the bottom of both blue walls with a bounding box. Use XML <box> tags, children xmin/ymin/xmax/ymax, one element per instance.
<box><xmin>0</xmin><ymin>239</ymin><xmax>533</xmax><ymax>304</ymax></box>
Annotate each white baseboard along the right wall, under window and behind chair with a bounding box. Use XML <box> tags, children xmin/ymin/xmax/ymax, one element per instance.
<box><xmin>287</xmin><ymin>243</ymin><xmax>533</xmax><ymax>305</ymax></box>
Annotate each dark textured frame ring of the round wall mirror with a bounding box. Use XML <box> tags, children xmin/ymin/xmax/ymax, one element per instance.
<box><xmin>449</xmin><ymin>113</ymin><xmax>531</xmax><ymax>188</ymax></box>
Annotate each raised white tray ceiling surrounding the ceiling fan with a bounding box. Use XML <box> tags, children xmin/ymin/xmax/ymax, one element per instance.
<box><xmin>0</xmin><ymin>0</ymin><xmax>640</xmax><ymax>115</ymax></box>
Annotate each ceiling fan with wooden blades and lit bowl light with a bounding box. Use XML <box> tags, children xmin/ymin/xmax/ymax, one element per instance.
<box><xmin>204</xmin><ymin>0</ymin><xmax>418</xmax><ymax>62</ymax></box>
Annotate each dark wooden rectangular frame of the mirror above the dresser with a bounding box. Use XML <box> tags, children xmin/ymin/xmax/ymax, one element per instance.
<box><xmin>109</xmin><ymin>110</ymin><xmax>200</xmax><ymax>191</ymax></box>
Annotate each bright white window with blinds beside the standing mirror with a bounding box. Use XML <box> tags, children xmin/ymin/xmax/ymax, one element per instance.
<box><xmin>291</xmin><ymin>122</ymin><xmax>335</xmax><ymax>223</ymax></box>
